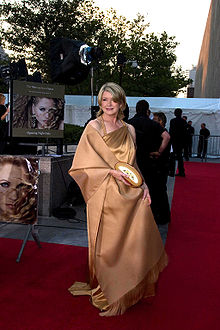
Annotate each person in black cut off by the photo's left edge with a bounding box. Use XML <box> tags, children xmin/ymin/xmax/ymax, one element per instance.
<box><xmin>0</xmin><ymin>93</ymin><xmax>10</xmax><ymax>155</ymax></box>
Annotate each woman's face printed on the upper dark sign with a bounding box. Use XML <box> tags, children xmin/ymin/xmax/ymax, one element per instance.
<box><xmin>32</xmin><ymin>98</ymin><xmax>56</xmax><ymax>128</ymax></box>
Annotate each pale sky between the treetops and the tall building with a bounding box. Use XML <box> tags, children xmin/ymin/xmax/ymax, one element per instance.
<box><xmin>95</xmin><ymin>0</ymin><xmax>211</xmax><ymax>70</ymax></box>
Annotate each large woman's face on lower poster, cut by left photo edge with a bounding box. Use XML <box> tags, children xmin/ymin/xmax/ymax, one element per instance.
<box><xmin>0</xmin><ymin>163</ymin><xmax>26</xmax><ymax>215</ymax></box>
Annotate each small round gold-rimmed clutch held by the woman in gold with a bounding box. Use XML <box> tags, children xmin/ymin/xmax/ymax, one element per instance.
<box><xmin>115</xmin><ymin>162</ymin><xmax>143</xmax><ymax>188</ymax></box>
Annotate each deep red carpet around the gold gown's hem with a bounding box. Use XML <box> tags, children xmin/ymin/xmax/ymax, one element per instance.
<box><xmin>0</xmin><ymin>163</ymin><xmax>220</xmax><ymax>330</ymax></box>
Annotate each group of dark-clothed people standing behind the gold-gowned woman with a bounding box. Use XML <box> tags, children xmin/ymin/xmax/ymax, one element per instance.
<box><xmin>128</xmin><ymin>100</ymin><xmax>210</xmax><ymax>225</ymax></box>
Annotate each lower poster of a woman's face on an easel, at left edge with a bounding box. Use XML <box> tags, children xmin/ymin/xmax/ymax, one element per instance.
<box><xmin>0</xmin><ymin>156</ymin><xmax>39</xmax><ymax>224</ymax></box>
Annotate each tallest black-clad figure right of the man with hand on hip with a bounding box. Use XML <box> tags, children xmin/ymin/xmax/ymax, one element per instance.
<box><xmin>169</xmin><ymin>108</ymin><xmax>187</xmax><ymax>177</ymax></box>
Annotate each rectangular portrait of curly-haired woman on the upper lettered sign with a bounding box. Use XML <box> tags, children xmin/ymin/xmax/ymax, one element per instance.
<box><xmin>13</xmin><ymin>95</ymin><xmax>64</xmax><ymax>130</ymax></box>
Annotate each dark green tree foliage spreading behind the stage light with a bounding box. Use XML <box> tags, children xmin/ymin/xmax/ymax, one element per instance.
<box><xmin>0</xmin><ymin>0</ymin><xmax>189</xmax><ymax>96</ymax></box>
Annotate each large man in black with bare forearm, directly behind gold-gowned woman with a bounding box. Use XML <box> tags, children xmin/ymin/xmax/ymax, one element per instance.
<box><xmin>128</xmin><ymin>100</ymin><xmax>170</xmax><ymax>225</ymax></box>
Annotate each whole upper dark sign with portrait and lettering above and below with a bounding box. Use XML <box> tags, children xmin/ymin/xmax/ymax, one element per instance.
<box><xmin>11</xmin><ymin>80</ymin><xmax>65</xmax><ymax>138</ymax></box>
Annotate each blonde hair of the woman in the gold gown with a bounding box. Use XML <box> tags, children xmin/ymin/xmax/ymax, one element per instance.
<box><xmin>97</xmin><ymin>82</ymin><xmax>126</xmax><ymax>119</ymax></box>
